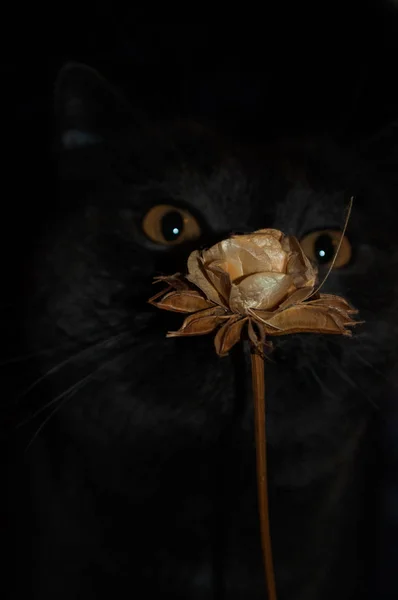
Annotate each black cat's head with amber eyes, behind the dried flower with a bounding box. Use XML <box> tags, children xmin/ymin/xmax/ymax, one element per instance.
<box><xmin>26</xmin><ymin>68</ymin><xmax>395</xmax><ymax>468</ymax></box>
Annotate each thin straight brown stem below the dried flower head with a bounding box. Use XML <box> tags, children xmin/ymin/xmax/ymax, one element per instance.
<box><xmin>251</xmin><ymin>347</ymin><xmax>277</xmax><ymax>600</ymax></box>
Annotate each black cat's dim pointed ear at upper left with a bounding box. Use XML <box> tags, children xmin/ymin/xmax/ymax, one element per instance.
<box><xmin>55</xmin><ymin>63</ymin><xmax>132</xmax><ymax>150</ymax></box>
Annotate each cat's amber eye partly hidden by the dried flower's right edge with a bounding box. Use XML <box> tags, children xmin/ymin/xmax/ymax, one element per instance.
<box><xmin>300</xmin><ymin>229</ymin><xmax>352</xmax><ymax>269</ymax></box>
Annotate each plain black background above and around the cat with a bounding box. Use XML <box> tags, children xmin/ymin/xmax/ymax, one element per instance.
<box><xmin>0</xmin><ymin>7</ymin><xmax>398</xmax><ymax>598</ymax></box>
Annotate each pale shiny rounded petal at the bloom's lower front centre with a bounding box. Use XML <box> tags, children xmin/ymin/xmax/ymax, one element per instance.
<box><xmin>229</xmin><ymin>273</ymin><xmax>292</xmax><ymax>314</ymax></box>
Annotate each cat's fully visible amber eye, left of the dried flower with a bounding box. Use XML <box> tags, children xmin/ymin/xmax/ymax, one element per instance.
<box><xmin>142</xmin><ymin>204</ymin><xmax>201</xmax><ymax>246</ymax></box>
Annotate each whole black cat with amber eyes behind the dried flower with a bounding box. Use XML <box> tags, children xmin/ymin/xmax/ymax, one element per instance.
<box><xmin>13</xmin><ymin>65</ymin><xmax>398</xmax><ymax>600</ymax></box>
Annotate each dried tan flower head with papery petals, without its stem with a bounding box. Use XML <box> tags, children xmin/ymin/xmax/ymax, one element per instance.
<box><xmin>149</xmin><ymin>229</ymin><xmax>357</xmax><ymax>356</ymax></box>
